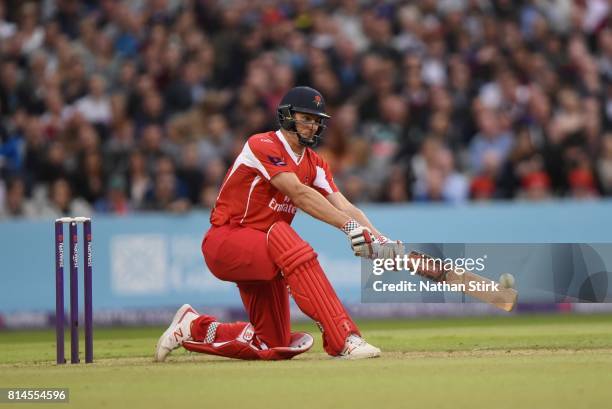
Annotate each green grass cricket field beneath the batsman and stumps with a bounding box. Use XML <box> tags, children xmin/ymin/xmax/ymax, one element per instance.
<box><xmin>0</xmin><ymin>315</ymin><xmax>612</xmax><ymax>409</ymax></box>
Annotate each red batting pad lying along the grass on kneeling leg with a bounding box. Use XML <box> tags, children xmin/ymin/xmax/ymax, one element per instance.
<box><xmin>183</xmin><ymin>324</ymin><xmax>314</xmax><ymax>361</ymax></box>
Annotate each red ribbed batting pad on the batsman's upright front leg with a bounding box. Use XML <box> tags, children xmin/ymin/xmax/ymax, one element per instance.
<box><xmin>268</xmin><ymin>222</ymin><xmax>361</xmax><ymax>356</ymax></box>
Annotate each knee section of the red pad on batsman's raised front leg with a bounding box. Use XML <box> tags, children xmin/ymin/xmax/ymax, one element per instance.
<box><xmin>268</xmin><ymin>222</ymin><xmax>317</xmax><ymax>275</ymax></box>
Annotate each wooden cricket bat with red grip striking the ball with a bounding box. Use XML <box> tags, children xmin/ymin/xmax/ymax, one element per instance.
<box><xmin>408</xmin><ymin>251</ymin><xmax>518</xmax><ymax>312</ymax></box>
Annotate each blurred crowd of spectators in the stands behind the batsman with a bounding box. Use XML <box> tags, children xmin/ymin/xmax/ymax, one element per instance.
<box><xmin>0</xmin><ymin>0</ymin><xmax>612</xmax><ymax>218</ymax></box>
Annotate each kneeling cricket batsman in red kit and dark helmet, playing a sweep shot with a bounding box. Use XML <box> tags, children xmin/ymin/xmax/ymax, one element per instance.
<box><xmin>155</xmin><ymin>87</ymin><xmax>403</xmax><ymax>361</ymax></box>
